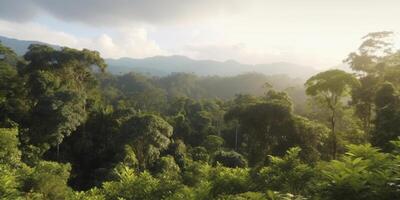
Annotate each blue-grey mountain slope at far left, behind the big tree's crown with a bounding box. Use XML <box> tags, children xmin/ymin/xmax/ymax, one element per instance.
<box><xmin>0</xmin><ymin>36</ymin><xmax>60</xmax><ymax>56</ymax></box>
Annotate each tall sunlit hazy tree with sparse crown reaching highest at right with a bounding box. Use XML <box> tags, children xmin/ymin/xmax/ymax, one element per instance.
<box><xmin>344</xmin><ymin>31</ymin><xmax>398</xmax><ymax>133</ymax></box>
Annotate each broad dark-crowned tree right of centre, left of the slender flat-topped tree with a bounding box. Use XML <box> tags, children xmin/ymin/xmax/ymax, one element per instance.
<box><xmin>225</xmin><ymin>92</ymin><xmax>292</xmax><ymax>166</ymax></box>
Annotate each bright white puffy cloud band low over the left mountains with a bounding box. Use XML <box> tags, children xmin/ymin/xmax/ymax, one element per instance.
<box><xmin>0</xmin><ymin>20</ymin><xmax>166</xmax><ymax>58</ymax></box>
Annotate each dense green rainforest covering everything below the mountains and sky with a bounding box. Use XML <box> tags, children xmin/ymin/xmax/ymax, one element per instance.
<box><xmin>0</xmin><ymin>32</ymin><xmax>400</xmax><ymax>200</ymax></box>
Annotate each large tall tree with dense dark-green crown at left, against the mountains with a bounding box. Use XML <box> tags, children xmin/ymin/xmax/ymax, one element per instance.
<box><xmin>19</xmin><ymin>44</ymin><xmax>106</xmax><ymax>158</ymax></box>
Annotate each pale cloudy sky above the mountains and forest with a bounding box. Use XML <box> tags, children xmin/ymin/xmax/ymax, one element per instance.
<box><xmin>0</xmin><ymin>0</ymin><xmax>400</xmax><ymax>69</ymax></box>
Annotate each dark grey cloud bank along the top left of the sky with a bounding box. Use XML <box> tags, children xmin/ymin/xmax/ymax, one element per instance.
<box><xmin>0</xmin><ymin>0</ymin><xmax>245</xmax><ymax>26</ymax></box>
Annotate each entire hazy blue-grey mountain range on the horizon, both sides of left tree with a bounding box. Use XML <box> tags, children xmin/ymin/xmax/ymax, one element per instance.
<box><xmin>0</xmin><ymin>36</ymin><xmax>318</xmax><ymax>78</ymax></box>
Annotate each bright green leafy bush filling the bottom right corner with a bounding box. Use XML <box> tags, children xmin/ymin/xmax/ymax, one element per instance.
<box><xmin>315</xmin><ymin>145</ymin><xmax>400</xmax><ymax>200</ymax></box>
